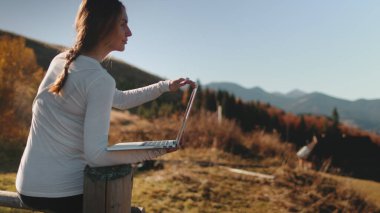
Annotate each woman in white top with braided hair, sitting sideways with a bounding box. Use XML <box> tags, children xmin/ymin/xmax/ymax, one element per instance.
<box><xmin>16</xmin><ymin>0</ymin><xmax>195</xmax><ymax>212</ymax></box>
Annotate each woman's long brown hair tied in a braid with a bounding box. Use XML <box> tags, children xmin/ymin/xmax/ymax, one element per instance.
<box><xmin>49</xmin><ymin>0</ymin><xmax>124</xmax><ymax>94</ymax></box>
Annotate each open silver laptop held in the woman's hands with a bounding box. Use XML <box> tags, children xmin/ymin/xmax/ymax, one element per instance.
<box><xmin>107</xmin><ymin>86</ymin><xmax>198</xmax><ymax>151</ymax></box>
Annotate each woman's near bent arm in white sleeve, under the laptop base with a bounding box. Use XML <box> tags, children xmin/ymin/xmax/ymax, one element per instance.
<box><xmin>84</xmin><ymin>76</ymin><xmax>166</xmax><ymax>166</ymax></box>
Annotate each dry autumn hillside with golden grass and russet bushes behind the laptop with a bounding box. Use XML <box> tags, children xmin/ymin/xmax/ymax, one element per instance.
<box><xmin>0</xmin><ymin>111</ymin><xmax>380</xmax><ymax>212</ymax></box>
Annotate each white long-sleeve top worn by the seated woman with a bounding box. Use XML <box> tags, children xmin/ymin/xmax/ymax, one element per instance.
<box><xmin>16</xmin><ymin>53</ymin><xmax>169</xmax><ymax>197</ymax></box>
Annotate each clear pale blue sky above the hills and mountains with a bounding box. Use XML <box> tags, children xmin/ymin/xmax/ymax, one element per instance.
<box><xmin>0</xmin><ymin>0</ymin><xmax>380</xmax><ymax>100</ymax></box>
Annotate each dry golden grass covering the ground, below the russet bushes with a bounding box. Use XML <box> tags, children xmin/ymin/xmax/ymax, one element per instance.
<box><xmin>0</xmin><ymin>148</ymin><xmax>380</xmax><ymax>212</ymax></box>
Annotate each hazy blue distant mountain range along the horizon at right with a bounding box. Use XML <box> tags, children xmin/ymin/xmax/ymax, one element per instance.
<box><xmin>204</xmin><ymin>82</ymin><xmax>380</xmax><ymax>133</ymax></box>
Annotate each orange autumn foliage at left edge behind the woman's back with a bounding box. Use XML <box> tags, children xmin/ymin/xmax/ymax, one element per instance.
<box><xmin>0</xmin><ymin>36</ymin><xmax>43</xmax><ymax>141</ymax></box>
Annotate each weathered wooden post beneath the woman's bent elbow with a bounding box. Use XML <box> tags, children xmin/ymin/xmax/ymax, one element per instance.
<box><xmin>83</xmin><ymin>165</ymin><xmax>133</xmax><ymax>213</ymax></box>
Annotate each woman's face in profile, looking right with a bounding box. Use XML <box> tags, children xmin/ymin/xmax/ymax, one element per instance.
<box><xmin>108</xmin><ymin>8</ymin><xmax>132</xmax><ymax>51</ymax></box>
